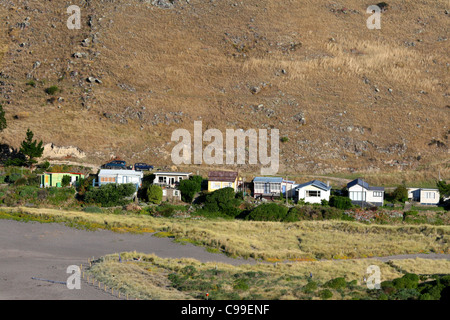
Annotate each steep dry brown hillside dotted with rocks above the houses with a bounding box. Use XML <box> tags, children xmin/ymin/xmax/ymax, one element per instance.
<box><xmin>0</xmin><ymin>0</ymin><xmax>450</xmax><ymax>180</ymax></box>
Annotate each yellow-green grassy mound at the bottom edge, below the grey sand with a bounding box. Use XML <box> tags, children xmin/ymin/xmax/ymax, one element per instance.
<box><xmin>88</xmin><ymin>252</ymin><xmax>450</xmax><ymax>300</ymax></box>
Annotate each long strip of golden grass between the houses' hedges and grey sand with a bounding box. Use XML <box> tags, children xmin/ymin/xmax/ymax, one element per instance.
<box><xmin>0</xmin><ymin>207</ymin><xmax>450</xmax><ymax>262</ymax></box>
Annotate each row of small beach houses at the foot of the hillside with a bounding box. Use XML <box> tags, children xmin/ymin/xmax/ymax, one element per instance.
<box><xmin>41</xmin><ymin>169</ymin><xmax>440</xmax><ymax>207</ymax></box>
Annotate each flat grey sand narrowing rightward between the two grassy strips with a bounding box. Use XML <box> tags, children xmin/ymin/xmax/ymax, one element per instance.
<box><xmin>0</xmin><ymin>220</ymin><xmax>450</xmax><ymax>300</ymax></box>
